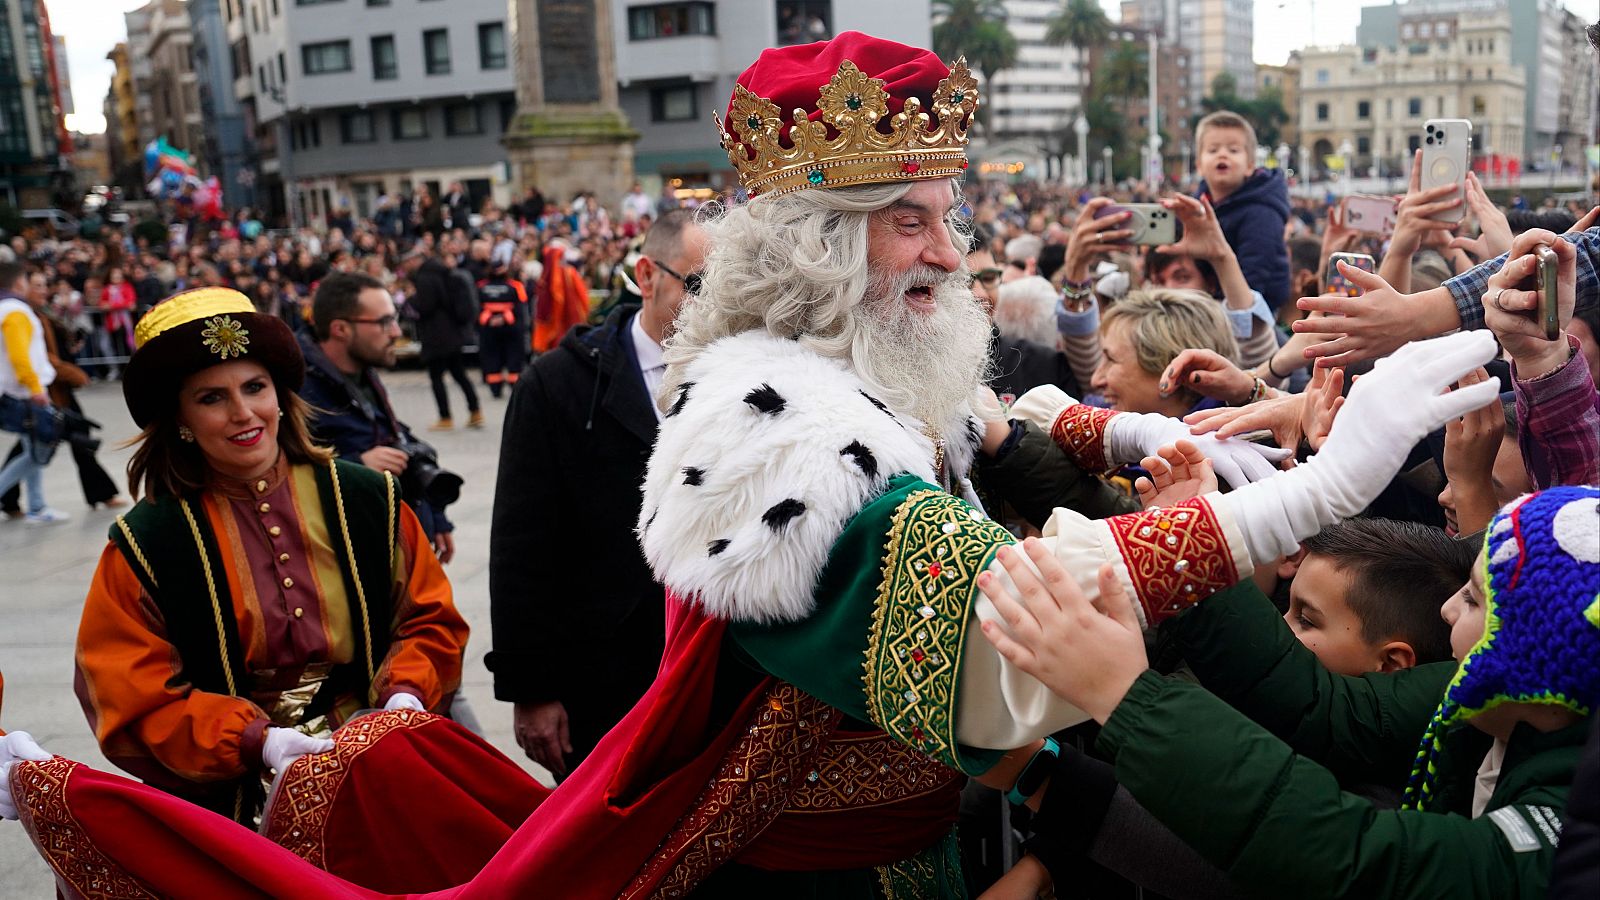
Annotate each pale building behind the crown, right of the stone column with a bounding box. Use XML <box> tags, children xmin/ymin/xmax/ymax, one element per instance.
<box><xmin>614</xmin><ymin>0</ymin><xmax>934</xmax><ymax>193</ymax></box>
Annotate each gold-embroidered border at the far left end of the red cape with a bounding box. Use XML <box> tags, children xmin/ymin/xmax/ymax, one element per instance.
<box><xmin>11</xmin><ymin>756</ymin><xmax>158</xmax><ymax>900</ymax></box>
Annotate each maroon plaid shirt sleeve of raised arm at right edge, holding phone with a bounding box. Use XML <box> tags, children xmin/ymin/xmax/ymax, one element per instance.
<box><xmin>1512</xmin><ymin>334</ymin><xmax>1600</xmax><ymax>490</ymax></box>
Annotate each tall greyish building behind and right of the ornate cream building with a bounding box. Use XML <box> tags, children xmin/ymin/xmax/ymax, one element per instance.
<box><xmin>1355</xmin><ymin>0</ymin><xmax>1595</xmax><ymax>170</ymax></box>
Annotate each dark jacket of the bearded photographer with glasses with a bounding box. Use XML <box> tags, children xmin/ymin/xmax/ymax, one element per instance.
<box><xmin>299</xmin><ymin>333</ymin><xmax>456</xmax><ymax>538</ymax></box>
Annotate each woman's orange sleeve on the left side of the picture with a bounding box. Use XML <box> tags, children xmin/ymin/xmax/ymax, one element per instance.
<box><xmin>75</xmin><ymin>543</ymin><xmax>267</xmax><ymax>781</ymax></box>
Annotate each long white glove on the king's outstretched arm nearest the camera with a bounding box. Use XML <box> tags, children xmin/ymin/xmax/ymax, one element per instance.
<box><xmin>1216</xmin><ymin>330</ymin><xmax>1499</xmax><ymax>565</ymax></box>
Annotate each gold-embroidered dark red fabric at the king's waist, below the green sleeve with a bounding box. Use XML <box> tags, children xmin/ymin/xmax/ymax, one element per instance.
<box><xmin>787</xmin><ymin>733</ymin><xmax>965</xmax><ymax>814</ymax></box>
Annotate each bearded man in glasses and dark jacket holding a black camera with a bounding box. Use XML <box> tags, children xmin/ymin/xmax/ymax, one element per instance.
<box><xmin>299</xmin><ymin>272</ymin><xmax>456</xmax><ymax>562</ymax></box>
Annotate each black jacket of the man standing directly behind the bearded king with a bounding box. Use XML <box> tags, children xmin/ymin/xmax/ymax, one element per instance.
<box><xmin>486</xmin><ymin>306</ymin><xmax>666</xmax><ymax>720</ymax></box>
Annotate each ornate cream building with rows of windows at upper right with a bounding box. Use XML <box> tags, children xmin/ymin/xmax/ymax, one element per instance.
<box><xmin>1299</xmin><ymin>8</ymin><xmax>1526</xmax><ymax>178</ymax></box>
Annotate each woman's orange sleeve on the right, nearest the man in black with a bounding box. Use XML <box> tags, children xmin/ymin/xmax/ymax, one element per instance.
<box><xmin>373</xmin><ymin>503</ymin><xmax>469</xmax><ymax>709</ymax></box>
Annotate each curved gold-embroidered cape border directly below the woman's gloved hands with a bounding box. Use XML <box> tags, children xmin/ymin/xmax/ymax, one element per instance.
<box><xmin>261</xmin><ymin>709</ymin><xmax>440</xmax><ymax>868</ymax></box>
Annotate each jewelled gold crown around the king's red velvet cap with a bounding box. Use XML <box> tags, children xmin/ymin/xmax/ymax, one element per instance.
<box><xmin>712</xmin><ymin>58</ymin><xmax>978</xmax><ymax>197</ymax></box>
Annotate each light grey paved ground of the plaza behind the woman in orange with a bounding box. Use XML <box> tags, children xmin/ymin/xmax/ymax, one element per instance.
<box><xmin>0</xmin><ymin>372</ymin><xmax>544</xmax><ymax>883</ymax></box>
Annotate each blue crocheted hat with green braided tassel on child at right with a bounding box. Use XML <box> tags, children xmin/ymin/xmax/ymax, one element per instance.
<box><xmin>1405</xmin><ymin>487</ymin><xmax>1600</xmax><ymax>809</ymax></box>
